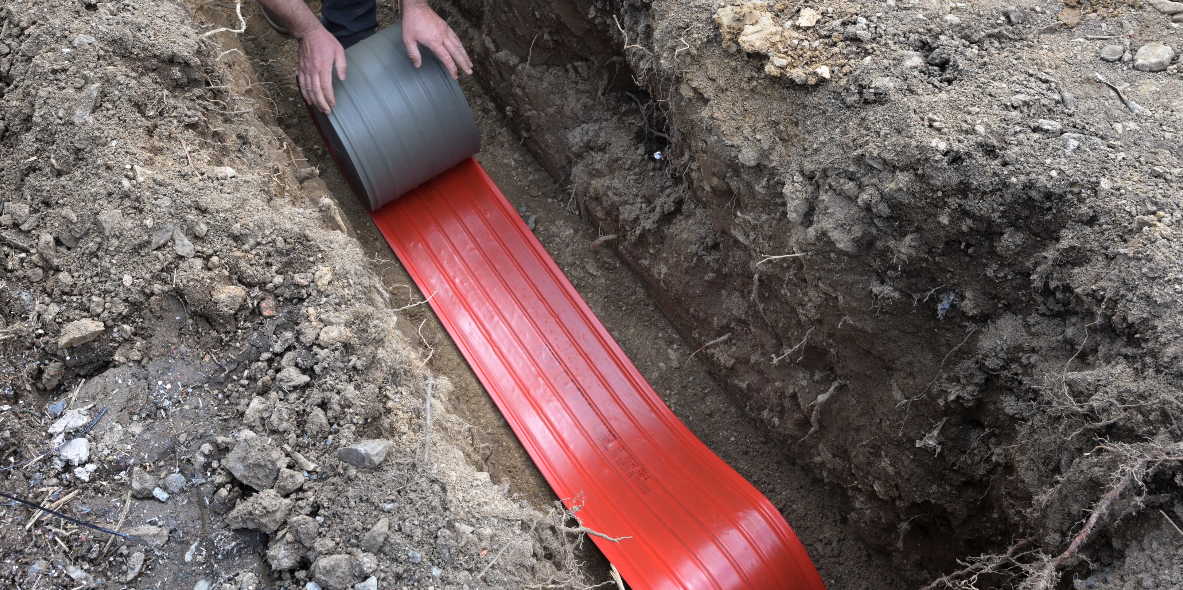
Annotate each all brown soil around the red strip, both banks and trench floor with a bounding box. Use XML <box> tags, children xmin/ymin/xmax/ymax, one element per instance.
<box><xmin>0</xmin><ymin>0</ymin><xmax>1183</xmax><ymax>590</ymax></box>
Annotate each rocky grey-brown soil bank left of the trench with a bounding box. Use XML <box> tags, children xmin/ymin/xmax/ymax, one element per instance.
<box><xmin>0</xmin><ymin>0</ymin><xmax>581</xmax><ymax>589</ymax></box>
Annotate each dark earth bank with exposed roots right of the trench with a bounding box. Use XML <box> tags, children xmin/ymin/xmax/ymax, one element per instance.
<box><xmin>442</xmin><ymin>0</ymin><xmax>1183</xmax><ymax>584</ymax></box>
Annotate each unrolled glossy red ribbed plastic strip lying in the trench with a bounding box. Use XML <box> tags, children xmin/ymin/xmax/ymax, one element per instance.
<box><xmin>371</xmin><ymin>158</ymin><xmax>825</xmax><ymax>590</ymax></box>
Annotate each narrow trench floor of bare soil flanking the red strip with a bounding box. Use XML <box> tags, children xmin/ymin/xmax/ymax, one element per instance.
<box><xmin>235</xmin><ymin>5</ymin><xmax>906</xmax><ymax>590</ymax></box>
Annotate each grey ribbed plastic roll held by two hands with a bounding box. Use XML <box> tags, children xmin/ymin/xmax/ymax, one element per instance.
<box><xmin>309</xmin><ymin>24</ymin><xmax>480</xmax><ymax>210</ymax></box>
